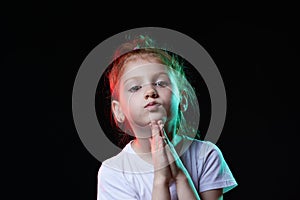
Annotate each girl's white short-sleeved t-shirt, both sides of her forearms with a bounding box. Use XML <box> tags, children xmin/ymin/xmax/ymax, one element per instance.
<box><xmin>97</xmin><ymin>140</ymin><xmax>237</xmax><ymax>200</ymax></box>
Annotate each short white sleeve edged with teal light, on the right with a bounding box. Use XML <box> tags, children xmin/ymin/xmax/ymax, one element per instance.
<box><xmin>199</xmin><ymin>142</ymin><xmax>237</xmax><ymax>193</ymax></box>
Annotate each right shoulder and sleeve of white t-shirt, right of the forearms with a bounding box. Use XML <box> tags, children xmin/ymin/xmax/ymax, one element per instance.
<box><xmin>179</xmin><ymin>139</ymin><xmax>237</xmax><ymax>193</ymax></box>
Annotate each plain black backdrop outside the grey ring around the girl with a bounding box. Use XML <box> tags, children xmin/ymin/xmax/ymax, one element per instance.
<box><xmin>1</xmin><ymin>2</ymin><xmax>299</xmax><ymax>200</ymax></box>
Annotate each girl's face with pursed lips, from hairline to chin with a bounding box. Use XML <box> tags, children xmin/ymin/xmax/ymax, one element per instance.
<box><xmin>113</xmin><ymin>59</ymin><xmax>174</xmax><ymax>133</ymax></box>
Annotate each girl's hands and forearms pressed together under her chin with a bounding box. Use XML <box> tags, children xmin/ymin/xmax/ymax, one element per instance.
<box><xmin>150</xmin><ymin>120</ymin><xmax>200</xmax><ymax>200</ymax></box>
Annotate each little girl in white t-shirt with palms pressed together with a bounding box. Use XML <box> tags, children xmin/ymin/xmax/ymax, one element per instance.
<box><xmin>97</xmin><ymin>36</ymin><xmax>237</xmax><ymax>200</ymax></box>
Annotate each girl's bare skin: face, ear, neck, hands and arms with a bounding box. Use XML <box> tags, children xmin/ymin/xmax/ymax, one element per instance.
<box><xmin>112</xmin><ymin>59</ymin><xmax>223</xmax><ymax>200</ymax></box>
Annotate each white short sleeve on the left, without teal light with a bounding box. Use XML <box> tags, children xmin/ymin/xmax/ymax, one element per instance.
<box><xmin>97</xmin><ymin>164</ymin><xmax>137</xmax><ymax>200</ymax></box>
